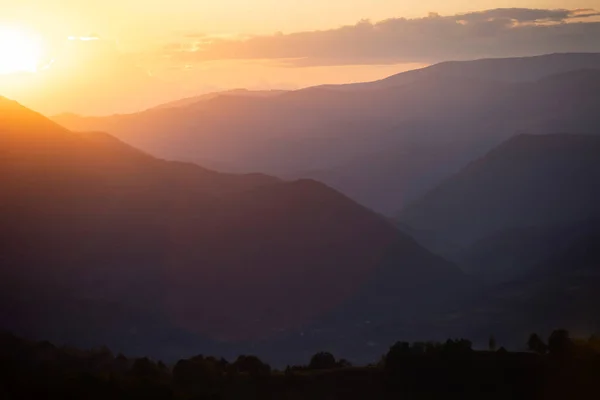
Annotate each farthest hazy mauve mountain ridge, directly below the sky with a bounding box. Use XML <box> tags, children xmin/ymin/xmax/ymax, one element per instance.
<box><xmin>55</xmin><ymin>54</ymin><xmax>600</xmax><ymax>215</ymax></box>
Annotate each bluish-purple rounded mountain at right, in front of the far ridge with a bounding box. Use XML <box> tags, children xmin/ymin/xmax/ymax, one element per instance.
<box><xmin>399</xmin><ymin>134</ymin><xmax>600</xmax><ymax>245</ymax></box>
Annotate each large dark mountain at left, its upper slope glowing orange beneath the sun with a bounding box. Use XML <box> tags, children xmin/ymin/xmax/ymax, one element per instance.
<box><xmin>0</xmin><ymin>99</ymin><xmax>463</xmax><ymax>360</ymax></box>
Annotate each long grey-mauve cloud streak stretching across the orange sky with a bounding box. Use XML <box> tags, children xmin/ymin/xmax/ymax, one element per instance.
<box><xmin>163</xmin><ymin>8</ymin><xmax>600</xmax><ymax>66</ymax></box>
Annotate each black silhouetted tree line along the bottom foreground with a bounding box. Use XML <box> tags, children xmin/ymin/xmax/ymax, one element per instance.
<box><xmin>0</xmin><ymin>330</ymin><xmax>600</xmax><ymax>400</ymax></box>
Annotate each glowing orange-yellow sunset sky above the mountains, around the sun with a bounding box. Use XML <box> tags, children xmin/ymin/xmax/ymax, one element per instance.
<box><xmin>0</xmin><ymin>0</ymin><xmax>600</xmax><ymax>115</ymax></box>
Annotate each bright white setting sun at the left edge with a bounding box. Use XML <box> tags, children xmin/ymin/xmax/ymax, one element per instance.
<box><xmin>0</xmin><ymin>26</ymin><xmax>42</xmax><ymax>74</ymax></box>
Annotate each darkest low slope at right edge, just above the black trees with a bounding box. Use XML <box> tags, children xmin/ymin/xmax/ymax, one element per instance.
<box><xmin>455</xmin><ymin>228</ymin><xmax>600</xmax><ymax>347</ymax></box>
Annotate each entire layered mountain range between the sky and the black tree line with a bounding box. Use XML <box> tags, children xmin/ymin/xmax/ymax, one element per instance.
<box><xmin>0</xmin><ymin>54</ymin><xmax>600</xmax><ymax>362</ymax></box>
